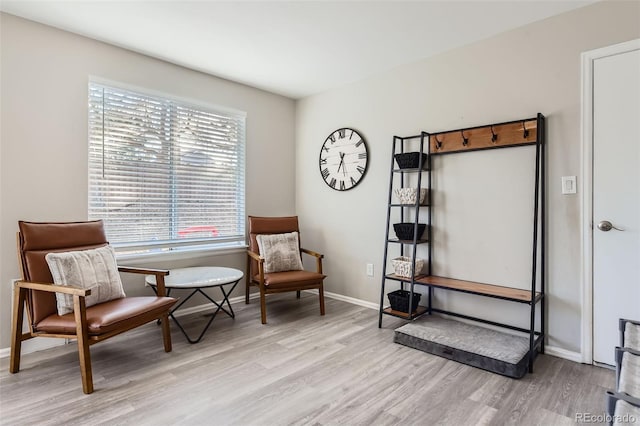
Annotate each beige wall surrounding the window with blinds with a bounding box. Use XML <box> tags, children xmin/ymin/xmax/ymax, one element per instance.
<box><xmin>0</xmin><ymin>14</ymin><xmax>295</xmax><ymax>348</ymax></box>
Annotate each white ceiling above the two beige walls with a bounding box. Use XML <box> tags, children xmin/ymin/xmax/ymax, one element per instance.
<box><xmin>0</xmin><ymin>0</ymin><xmax>594</xmax><ymax>98</ymax></box>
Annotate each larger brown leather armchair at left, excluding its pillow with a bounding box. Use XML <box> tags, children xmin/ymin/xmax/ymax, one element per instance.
<box><xmin>9</xmin><ymin>220</ymin><xmax>177</xmax><ymax>394</ymax></box>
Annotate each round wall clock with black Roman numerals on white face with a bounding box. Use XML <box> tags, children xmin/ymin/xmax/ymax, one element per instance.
<box><xmin>320</xmin><ymin>128</ymin><xmax>368</xmax><ymax>191</ymax></box>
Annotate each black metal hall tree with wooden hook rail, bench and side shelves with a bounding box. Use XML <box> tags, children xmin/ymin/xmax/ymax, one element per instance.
<box><xmin>378</xmin><ymin>113</ymin><xmax>546</xmax><ymax>372</ymax></box>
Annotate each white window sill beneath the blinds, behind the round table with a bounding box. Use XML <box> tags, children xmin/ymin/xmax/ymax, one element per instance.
<box><xmin>116</xmin><ymin>243</ymin><xmax>247</xmax><ymax>266</ymax></box>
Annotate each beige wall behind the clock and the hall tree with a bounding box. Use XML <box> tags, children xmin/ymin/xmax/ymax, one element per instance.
<box><xmin>296</xmin><ymin>1</ymin><xmax>640</xmax><ymax>352</ymax></box>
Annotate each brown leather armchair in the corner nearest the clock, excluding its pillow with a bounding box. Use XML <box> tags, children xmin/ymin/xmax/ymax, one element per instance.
<box><xmin>245</xmin><ymin>216</ymin><xmax>325</xmax><ymax>324</ymax></box>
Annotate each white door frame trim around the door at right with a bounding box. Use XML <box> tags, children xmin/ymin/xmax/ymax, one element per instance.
<box><xmin>580</xmin><ymin>39</ymin><xmax>640</xmax><ymax>364</ymax></box>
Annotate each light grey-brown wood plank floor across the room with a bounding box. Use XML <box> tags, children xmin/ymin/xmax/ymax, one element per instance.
<box><xmin>0</xmin><ymin>293</ymin><xmax>614</xmax><ymax>425</ymax></box>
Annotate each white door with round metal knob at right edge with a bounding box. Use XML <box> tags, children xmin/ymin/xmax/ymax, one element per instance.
<box><xmin>593</xmin><ymin>44</ymin><xmax>640</xmax><ymax>365</ymax></box>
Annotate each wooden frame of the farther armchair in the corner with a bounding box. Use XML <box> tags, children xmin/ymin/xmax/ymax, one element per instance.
<box><xmin>245</xmin><ymin>216</ymin><xmax>325</xmax><ymax>324</ymax></box>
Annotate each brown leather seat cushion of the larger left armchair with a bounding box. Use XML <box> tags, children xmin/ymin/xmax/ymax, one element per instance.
<box><xmin>35</xmin><ymin>296</ymin><xmax>178</xmax><ymax>335</ymax></box>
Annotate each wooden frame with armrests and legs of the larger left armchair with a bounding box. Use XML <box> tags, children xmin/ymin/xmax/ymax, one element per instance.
<box><xmin>9</xmin><ymin>221</ymin><xmax>177</xmax><ymax>394</ymax></box>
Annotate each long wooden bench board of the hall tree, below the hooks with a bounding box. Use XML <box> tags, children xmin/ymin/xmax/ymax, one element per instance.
<box><xmin>414</xmin><ymin>275</ymin><xmax>542</xmax><ymax>303</ymax></box>
